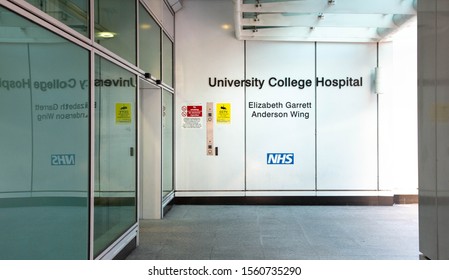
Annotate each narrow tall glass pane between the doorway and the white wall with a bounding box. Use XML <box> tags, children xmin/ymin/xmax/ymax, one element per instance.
<box><xmin>162</xmin><ymin>90</ymin><xmax>173</xmax><ymax>197</ymax></box>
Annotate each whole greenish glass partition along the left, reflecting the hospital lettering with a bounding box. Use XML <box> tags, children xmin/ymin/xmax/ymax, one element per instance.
<box><xmin>0</xmin><ymin>0</ymin><xmax>173</xmax><ymax>260</ymax></box>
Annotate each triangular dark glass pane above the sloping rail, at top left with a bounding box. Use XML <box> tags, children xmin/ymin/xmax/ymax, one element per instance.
<box><xmin>27</xmin><ymin>0</ymin><xmax>89</xmax><ymax>37</ymax></box>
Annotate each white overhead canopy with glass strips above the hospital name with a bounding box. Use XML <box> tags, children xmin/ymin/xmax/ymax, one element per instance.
<box><xmin>234</xmin><ymin>0</ymin><xmax>417</xmax><ymax>42</ymax></box>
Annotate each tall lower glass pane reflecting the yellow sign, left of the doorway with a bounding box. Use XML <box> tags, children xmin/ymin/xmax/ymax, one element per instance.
<box><xmin>94</xmin><ymin>57</ymin><xmax>137</xmax><ymax>256</ymax></box>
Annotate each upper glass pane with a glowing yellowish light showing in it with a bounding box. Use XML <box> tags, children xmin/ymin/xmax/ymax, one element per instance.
<box><xmin>95</xmin><ymin>0</ymin><xmax>136</xmax><ymax>64</ymax></box>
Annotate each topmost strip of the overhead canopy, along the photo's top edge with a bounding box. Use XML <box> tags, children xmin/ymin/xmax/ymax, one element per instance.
<box><xmin>241</xmin><ymin>0</ymin><xmax>416</xmax><ymax>15</ymax></box>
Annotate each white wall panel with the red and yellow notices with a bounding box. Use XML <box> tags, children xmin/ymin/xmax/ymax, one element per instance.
<box><xmin>175</xmin><ymin>1</ymin><xmax>245</xmax><ymax>195</ymax></box>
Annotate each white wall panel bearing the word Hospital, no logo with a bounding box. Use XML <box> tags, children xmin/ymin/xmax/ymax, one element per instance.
<box><xmin>316</xmin><ymin>43</ymin><xmax>377</xmax><ymax>190</ymax></box>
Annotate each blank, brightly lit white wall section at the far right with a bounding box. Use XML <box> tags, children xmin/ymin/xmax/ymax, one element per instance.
<box><xmin>379</xmin><ymin>20</ymin><xmax>418</xmax><ymax>193</ymax></box>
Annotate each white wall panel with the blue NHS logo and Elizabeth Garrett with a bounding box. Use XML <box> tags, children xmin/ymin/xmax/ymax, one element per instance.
<box><xmin>246</xmin><ymin>41</ymin><xmax>315</xmax><ymax>191</ymax></box>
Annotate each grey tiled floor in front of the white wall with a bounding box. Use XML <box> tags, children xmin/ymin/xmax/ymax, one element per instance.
<box><xmin>127</xmin><ymin>204</ymin><xmax>419</xmax><ymax>260</ymax></box>
